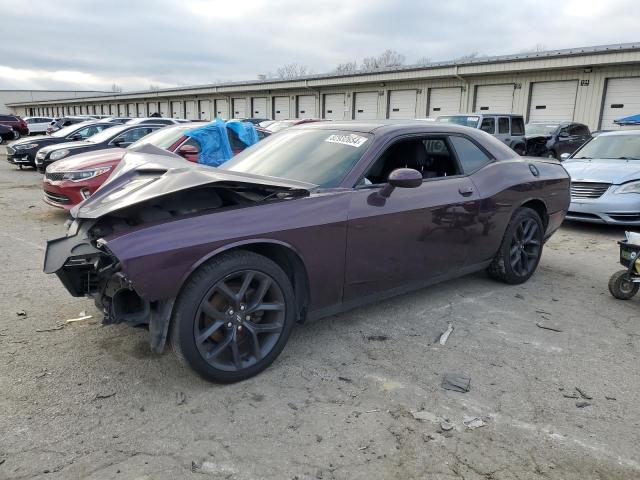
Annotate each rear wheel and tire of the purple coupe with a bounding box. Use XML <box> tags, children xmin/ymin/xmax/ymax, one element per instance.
<box><xmin>487</xmin><ymin>207</ymin><xmax>544</xmax><ymax>285</ymax></box>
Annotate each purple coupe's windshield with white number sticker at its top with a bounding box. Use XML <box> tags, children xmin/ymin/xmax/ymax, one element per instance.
<box><xmin>220</xmin><ymin>129</ymin><xmax>371</xmax><ymax>188</ymax></box>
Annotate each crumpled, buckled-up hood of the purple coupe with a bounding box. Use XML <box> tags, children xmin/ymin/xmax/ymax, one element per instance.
<box><xmin>70</xmin><ymin>145</ymin><xmax>317</xmax><ymax>218</ymax></box>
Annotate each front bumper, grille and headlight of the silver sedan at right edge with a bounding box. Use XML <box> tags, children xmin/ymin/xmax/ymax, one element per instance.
<box><xmin>567</xmin><ymin>187</ymin><xmax>640</xmax><ymax>225</ymax></box>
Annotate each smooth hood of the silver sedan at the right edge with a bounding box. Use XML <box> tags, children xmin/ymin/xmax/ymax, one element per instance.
<box><xmin>562</xmin><ymin>158</ymin><xmax>640</xmax><ymax>185</ymax></box>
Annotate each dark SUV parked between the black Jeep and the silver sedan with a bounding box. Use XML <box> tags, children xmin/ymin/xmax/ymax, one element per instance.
<box><xmin>525</xmin><ymin>122</ymin><xmax>591</xmax><ymax>160</ymax></box>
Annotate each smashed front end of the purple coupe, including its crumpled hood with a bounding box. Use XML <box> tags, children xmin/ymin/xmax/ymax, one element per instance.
<box><xmin>44</xmin><ymin>143</ymin><xmax>313</xmax><ymax>353</ymax></box>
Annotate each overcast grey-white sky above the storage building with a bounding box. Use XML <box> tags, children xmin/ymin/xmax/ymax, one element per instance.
<box><xmin>0</xmin><ymin>0</ymin><xmax>640</xmax><ymax>90</ymax></box>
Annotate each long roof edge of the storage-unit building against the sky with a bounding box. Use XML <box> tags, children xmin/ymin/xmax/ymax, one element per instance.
<box><xmin>6</xmin><ymin>42</ymin><xmax>640</xmax><ymax>106</ymax></box>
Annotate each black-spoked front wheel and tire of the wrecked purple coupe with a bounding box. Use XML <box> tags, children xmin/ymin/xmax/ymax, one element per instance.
<box><xmin>170</xmin><ymin>251</ymin><xmax>296</xmax><ymax>383</ymax></box>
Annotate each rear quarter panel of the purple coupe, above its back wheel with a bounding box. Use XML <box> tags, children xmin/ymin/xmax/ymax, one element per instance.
<box><xmin>471</xmin><ymin>157</ymin><xmax>570</xmax><ymax>261</ymax></box>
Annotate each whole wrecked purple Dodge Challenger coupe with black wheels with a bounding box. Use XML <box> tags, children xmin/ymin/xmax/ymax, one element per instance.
<box><xmin>45</xmin><ymin>121</ymin><xmax>570</xmax><ymax>382</ymax></box>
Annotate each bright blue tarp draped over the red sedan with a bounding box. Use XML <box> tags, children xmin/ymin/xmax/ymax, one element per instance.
<box><xmin>184</xmin><ymin>118</ymin><xmax>258</xmax><ymax>167</ymax></box>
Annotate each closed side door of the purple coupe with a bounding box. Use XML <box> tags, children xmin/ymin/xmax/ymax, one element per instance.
<box><xmin>344</xmin><ymin>135</ymin><xmax>479</xmax><ymax>301</ymax></box>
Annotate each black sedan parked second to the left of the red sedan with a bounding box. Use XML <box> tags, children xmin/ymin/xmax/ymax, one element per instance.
<box><xmin>7</xmin><ymin>120</ymin><xmax>115</xmax><ymax>168</ymax></box>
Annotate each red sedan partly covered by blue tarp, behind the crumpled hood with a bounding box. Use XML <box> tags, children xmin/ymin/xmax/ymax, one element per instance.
<box><xmin>42</xmin><ymin>124</ymin><xmax>271</xmax><ymax>210</ymax></box>
